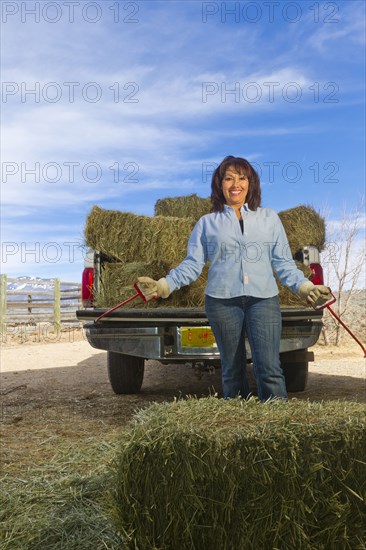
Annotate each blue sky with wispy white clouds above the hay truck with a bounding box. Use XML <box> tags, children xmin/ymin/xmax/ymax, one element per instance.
<box><xmin>1</xmin><ymin>0</ymin><xmax>365</xmax><ymax>282</ymax></box>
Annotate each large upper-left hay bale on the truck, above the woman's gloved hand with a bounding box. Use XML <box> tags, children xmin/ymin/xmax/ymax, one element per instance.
<box><xmin>84</xmin><ymin>206</ymin><xmax>195</xmax><ymax>265</ymax></box>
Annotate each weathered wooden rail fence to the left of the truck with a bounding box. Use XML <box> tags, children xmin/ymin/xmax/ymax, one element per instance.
<box><xmin>0</xmin><ymin>275</ymin><xmax>81</xmax><ymax>333</ymax></box>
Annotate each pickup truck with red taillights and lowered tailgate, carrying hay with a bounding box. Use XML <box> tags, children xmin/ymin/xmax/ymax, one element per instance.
<box><xmin>76</xmin><ymin>246</ymin><xmax>323</xmax><ymax>394</ymax></box>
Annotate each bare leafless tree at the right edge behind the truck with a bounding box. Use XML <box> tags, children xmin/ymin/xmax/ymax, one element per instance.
<box><xmin>322</xmin><ymin>198</ymin><xmax>366</xmax><ymax>346</ymax></box>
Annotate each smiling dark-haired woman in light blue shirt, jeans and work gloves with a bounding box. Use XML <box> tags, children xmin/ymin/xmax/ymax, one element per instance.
<box><xmin>138</xmin><ymin>156</ymin><xmax>329</xmax><ymax>401</ymax></box>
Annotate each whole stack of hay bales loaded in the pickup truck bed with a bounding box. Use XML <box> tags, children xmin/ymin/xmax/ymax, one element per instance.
<box><xmin>85</xmin><ymin>202</ymin><xmax>325</xmax><ymax>308</ymax></box>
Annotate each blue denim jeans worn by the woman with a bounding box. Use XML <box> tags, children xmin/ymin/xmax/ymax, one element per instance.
<box><xmin>206</xmin><ymin>295</ymin><xmax>287</xmax><ymax>401</ymax></box>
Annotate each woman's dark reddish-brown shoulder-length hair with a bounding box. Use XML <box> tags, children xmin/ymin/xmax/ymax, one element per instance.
<box><xmin>211</xmin><ymin>155</ymin><xmax>261</xmax><ymax>216</ymax></box>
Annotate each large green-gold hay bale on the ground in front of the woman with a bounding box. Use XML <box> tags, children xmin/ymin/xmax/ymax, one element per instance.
<box><xmin>112</xmin><ymin>398</ymin><xmax>366</xmax><ymax>550</ymax></box>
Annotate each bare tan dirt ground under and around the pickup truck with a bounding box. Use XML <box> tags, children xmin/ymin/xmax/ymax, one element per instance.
<box><xmin>0</xmin><ymin>330</ymin><xmax>366</xmax><ymax>427</ymax></box>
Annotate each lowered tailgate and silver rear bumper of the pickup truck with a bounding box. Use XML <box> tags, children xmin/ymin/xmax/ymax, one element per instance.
<box><xmin>78</xmin><ymin>310</ymin><xmax>323</xmax><ymax>363</ymax></box>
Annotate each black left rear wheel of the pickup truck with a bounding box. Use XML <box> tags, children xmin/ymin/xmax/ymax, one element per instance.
<box><xmin>108</xmin><ymin>351</ymin><xmax>145</xmax><ymax>394</ymax></box>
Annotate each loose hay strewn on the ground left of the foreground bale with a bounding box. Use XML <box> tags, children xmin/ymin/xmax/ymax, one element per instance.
<box><xmin>0</xmin><ymin>421</ymin><xmax>121</xmax><ymax>550</ymax></box>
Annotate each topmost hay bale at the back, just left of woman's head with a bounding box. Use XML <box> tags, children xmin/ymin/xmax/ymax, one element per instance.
<box><xmin>155</xmin><ymin>194</ymin><xmax>212</xmax><ymax>221</ymax></box>
